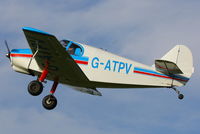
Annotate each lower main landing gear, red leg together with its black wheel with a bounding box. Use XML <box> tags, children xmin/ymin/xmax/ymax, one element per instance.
<box><xmin>42</xmin><ymin>81</ymin><xmax>58</xmax><ymax>110</ymax></box>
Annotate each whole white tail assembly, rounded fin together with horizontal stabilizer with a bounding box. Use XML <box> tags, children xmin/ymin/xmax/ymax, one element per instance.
<box><xmin>155</xmin><ymin>45</ymin><xmax>194</xmax><ymax>86</ymax></box>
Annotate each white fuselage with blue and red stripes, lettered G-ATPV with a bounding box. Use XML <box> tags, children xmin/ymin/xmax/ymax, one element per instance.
<box><xmin>11</xmin><ymin>43</ymin><xmax>188</xmax><ymax>88</ymax></box>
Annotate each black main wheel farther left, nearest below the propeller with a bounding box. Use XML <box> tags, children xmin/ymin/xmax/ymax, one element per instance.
<box><xmin>28</xmin><ymin>80</ymin><xmax>43</xmax><ymax>96</ymax></box>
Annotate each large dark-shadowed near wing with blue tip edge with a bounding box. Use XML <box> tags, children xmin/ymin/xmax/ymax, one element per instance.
<box><xmin>23</xmin><ymin>27</ymin><xmax>89</xmax><ymax>82</ymax></box>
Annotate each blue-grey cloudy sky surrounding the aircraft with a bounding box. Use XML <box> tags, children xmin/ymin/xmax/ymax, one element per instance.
<box><xmin>0</xmin><ymin>0</ymin><xmax>200</xmax><ymax>134</ymax></box>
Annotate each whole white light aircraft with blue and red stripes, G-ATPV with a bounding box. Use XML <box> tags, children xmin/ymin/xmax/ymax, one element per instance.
<box><xmin>5</xmin><ymin>27</ymin><xmax>194</xmax><ymax>110</ymax></box>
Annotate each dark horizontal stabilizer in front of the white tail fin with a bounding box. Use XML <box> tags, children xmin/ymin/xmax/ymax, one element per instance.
<box><xmin>155</xmin><ymin>60</ymin><xmax>183</xmax><ymax>74</ymax></box>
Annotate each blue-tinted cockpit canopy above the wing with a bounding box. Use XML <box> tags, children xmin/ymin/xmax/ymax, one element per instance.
<box><xmin>60</xmin><ymin>40</ymin><xmax>84</xmax><ymax>56</ymax></box>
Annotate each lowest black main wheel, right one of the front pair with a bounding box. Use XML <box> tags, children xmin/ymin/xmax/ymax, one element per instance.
<box><xmin>42</xmin><ymin>95</ymin><xmax>57</xmax><ymax>110</ymax></box>
